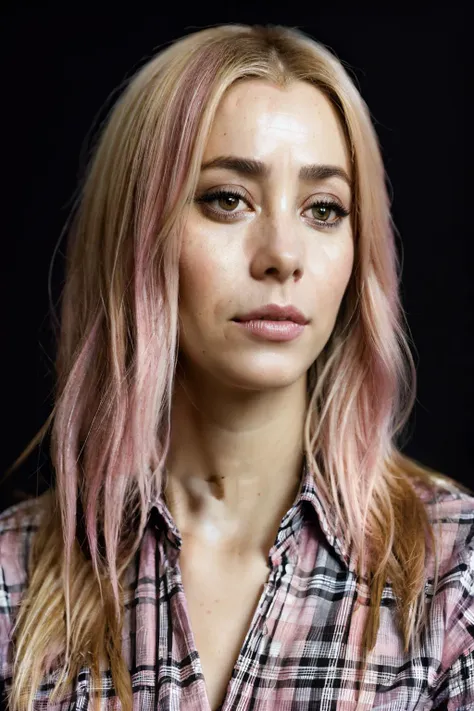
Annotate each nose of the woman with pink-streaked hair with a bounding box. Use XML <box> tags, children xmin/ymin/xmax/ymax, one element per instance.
<box><xmin>250</xmin><ymin>215</ymin><xmax>304</xmax><ymax>282</ymax></box>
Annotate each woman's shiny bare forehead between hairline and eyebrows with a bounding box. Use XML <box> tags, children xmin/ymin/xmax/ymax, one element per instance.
<box><xmin>204</xmin><ymin>79</ymin><xmax>350</xmax><ymax>172</ymax></box>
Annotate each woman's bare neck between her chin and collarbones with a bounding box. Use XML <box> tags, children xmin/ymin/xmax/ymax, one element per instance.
<box><xmin>164</xmin><ymin>376</ymin><xmax>307</xmax><ymax>556</ymax></box>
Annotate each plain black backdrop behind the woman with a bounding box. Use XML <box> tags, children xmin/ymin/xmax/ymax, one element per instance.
<box><xmin>0</xmin><ymin>3</ymin><xmax>473</xmax><ymax>510</ymax></box>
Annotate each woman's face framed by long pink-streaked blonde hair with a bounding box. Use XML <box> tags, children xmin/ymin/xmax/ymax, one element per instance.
<box><xmin>179</xmin><ymin>79</ymin><xmax>354</xmax><ymax>391</ymax></box>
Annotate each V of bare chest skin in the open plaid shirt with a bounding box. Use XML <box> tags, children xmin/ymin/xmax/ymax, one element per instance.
<box><xmin>180</xmin><ymin>551</ymin><xmax>270</xmax><ymax>711</ymax></box>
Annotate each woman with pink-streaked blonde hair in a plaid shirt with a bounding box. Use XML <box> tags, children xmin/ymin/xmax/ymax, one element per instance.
<box><xmin>0</xmin><ymin>25</ymin><xmax>474</xmax><ymax>711</ymax></box>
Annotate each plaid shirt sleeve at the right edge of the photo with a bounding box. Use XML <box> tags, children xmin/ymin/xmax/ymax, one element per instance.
<box><xmin>432</xmin><ymin>527</ymin><xmax>474</xmax><ymax>711</ymax></box>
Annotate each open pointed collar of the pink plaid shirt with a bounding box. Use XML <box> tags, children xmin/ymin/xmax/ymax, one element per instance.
<box><xmin>149</xmin><ymin>457</ymin><xmax>356</xmax><ymax>573</ymax></box>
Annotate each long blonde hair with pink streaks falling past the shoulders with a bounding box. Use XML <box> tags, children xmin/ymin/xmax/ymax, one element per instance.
<box><xmin>2</xmin><ymin>24</ymin><xmax>466</xmax><ymax>711</ymax></box>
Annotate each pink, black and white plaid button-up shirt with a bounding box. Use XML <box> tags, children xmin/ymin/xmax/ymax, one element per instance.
<box><xmin>0</xmin><ymin>458</ymin><xmax>474</xmax><ymax>711</ymax></box>
